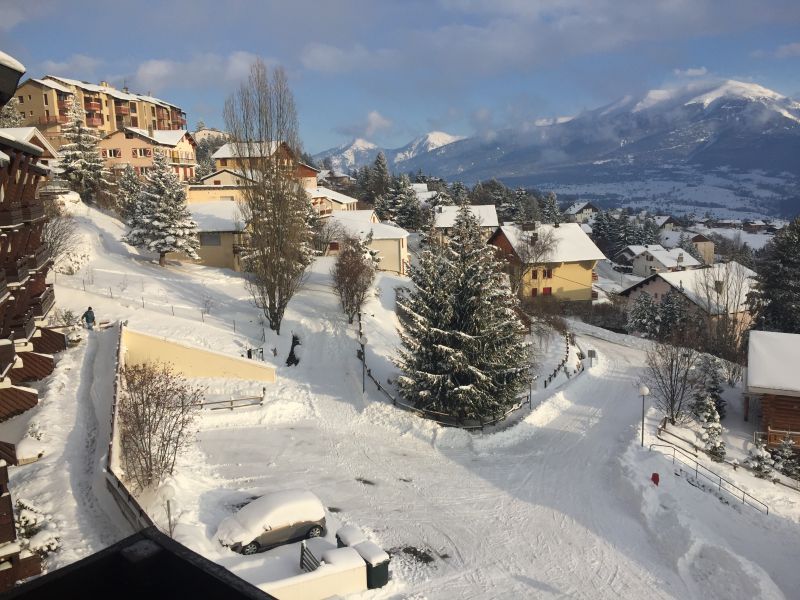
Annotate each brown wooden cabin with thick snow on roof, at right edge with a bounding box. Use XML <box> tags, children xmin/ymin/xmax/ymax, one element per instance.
<box><xmin>745</xmin><ymin>331</ymin><xmax>800</xmax><ymax>447</ymax></box>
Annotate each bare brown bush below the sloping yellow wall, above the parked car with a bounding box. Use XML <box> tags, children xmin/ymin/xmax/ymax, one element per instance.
<box><xmin>118</xmin><ymin>362</ymin><xmax>203</xmax><ymax>490</ymax></box>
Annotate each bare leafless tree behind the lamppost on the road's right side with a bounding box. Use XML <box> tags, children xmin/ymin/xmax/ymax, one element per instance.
<box><xmin>644</xmin><ymin>343</ymin><xmax>700</xmax><ymax>425</ymax></box>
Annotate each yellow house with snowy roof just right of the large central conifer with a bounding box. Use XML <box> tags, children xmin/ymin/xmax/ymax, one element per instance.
<box><xmin>489</xmin><ymin>223</ymin><xmax>605</xmax><ymax>302</ymax></box>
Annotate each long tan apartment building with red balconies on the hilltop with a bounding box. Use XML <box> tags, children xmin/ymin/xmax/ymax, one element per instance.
<box><xmin>16</xmin><ymin>75</ymin><xmax>186</xmax><ymax>149</ymax></box>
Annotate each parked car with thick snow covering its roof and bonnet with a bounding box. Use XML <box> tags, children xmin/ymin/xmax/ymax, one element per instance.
<box><xmin>217</xmin><ymin>490</ymin><xmax>325</xmax><ymax>554</ymax></box>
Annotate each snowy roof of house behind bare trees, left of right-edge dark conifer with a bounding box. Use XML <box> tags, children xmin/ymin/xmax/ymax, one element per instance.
<box><xmin>620</xmin><ymin>261</ymin><xmax>756</xmax><ymax>315</ymax></box>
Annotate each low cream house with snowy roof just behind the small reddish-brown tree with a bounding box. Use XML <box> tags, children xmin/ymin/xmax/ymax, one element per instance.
<box><xmin>327</xmin><ymin>210</ymin><xmax>409</xmax><ymax>275</ymax></box>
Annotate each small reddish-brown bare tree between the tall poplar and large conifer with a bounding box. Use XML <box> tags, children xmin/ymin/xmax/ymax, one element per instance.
<box><xmin>331</xmin><ymin>236</ymin><xmax>375</xmax><ymax>323</ymax></box>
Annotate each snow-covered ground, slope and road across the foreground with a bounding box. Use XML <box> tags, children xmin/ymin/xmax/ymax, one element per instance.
<box><xmin>2</xmin><ymin>200</ymin><xmax>800</xmax><ymax>600</ymax></box>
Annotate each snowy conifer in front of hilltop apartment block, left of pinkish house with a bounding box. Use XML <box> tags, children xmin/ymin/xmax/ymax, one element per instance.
<box><xmin>59</xmin><ymin>99</ymin><xmax>112</xmax><ymax>201</ymax></box>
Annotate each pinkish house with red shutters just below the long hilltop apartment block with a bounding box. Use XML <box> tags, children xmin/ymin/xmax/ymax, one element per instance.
<box><xmin>97</xmin><ymin>127</ymin><xmax>197</xmax><ymax>182</ymax></box>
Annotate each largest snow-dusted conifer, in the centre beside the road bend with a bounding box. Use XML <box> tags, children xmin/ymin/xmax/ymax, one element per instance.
<box><xmin>397</xmin><ymin>208</ymin><xmax>530</xmax><ymax>419</ymax></box>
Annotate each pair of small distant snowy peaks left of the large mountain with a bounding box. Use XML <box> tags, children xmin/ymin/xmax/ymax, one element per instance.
<box><xmin>314</xmin><ymin>131</ymin><xmax>464</xmax><ymax>171</ymax></box>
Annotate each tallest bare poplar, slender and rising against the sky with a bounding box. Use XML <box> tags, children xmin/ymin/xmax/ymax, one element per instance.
<box><xmin>225</xmin><ymin>60</ymin><xmax>313</xmax><ymax>334</ymax></box>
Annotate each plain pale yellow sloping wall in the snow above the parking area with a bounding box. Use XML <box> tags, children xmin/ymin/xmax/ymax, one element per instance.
<box><xmin>122</xmin><ymin>327</ymin><xmax>276</xmax><ymax>383</ymax></box>
